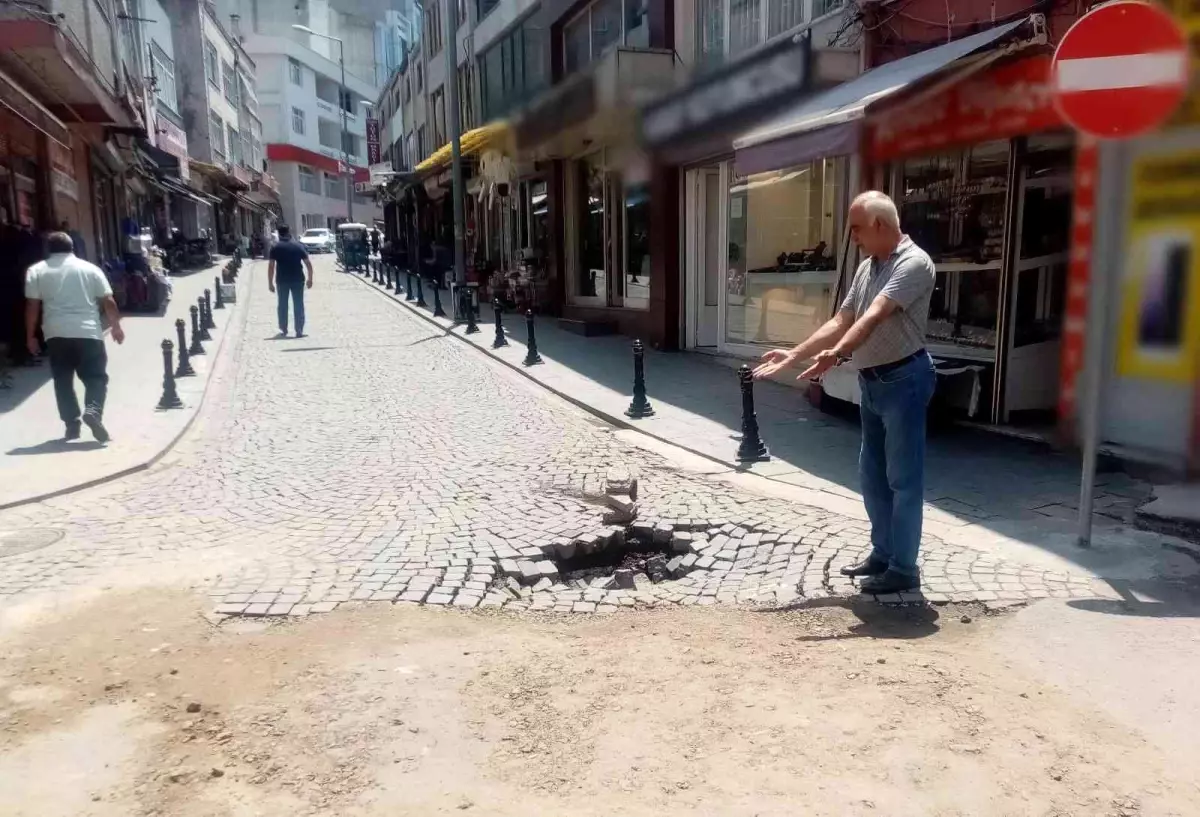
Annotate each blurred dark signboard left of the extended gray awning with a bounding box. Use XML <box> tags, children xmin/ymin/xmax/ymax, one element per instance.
<box><xmin>642</xmin><ymin>30</ymin><xmax>812</xmax><ymax>150</ymax></box>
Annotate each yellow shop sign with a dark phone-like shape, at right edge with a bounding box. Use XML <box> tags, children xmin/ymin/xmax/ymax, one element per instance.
<box><xmin>1117</xmin><ymin>149</ymin><xmax>1200</xmax><ymax>384</ymax></box>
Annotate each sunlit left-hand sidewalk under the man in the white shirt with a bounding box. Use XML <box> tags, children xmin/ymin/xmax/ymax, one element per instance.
<box><xmin>0</xmin><ymin>257</ymin><xmax>243</xmax><ymax>509</ymax></box>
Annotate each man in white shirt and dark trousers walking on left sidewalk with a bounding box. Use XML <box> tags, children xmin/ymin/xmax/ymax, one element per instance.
<box><xmin>25</xmin><ymin>233</ymin><xmax>125</xmax><ymax>443</ymax></box>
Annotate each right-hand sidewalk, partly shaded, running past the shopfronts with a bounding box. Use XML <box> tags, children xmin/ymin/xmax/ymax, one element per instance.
<box><xmin>358</xmin><ymin>276</ymin><xmax>1187</xmax><ymax>579</ymax></box>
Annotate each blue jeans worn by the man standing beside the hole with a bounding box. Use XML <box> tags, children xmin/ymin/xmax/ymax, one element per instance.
<box><xmin>858</xmin><ymin>352</ymin><xmax>937</xmax><ymax>576</ymax></box>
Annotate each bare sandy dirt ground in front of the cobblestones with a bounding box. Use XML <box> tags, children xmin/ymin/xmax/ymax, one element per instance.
<box><xmin>0</xmin><ymin>590</ymin><xmax>1200</xmax><ymax>817</ymax></box>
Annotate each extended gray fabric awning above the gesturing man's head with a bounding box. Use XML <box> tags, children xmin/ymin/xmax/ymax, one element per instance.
<box><xmin>733</xmin><ymin>17</ymin><xmax>1044</xmax><ymax>175</ymax></box>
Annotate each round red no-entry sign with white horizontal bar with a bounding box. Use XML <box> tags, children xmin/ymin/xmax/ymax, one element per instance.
<box><xmin>1051</xmin><ymin>0</ymin><xmax>1189</xmax><ymax>139</ymax></box>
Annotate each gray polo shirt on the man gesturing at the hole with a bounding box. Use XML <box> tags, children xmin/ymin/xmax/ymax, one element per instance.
<box><xmin>841</xmin><ymin>235</ymin><xmax>936</xmax><ymax>368</ymax></box>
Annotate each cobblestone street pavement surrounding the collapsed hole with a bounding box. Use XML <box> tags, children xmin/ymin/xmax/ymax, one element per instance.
<box><xmin>0</xmin><ymin>260</ymin><xmax>1104</xmax><ymax>615</ymax></box>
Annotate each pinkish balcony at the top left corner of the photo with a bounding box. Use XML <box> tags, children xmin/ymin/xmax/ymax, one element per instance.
<box><xmin>0</xmin><ymin>0</ymin><xmax>133</xmax><ymax>126</ymax></box>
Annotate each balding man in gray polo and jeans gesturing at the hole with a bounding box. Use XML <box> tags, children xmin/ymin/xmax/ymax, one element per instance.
<box><xmin>755</xmin><ymin>191</ymin><xmax>936</xmax><ymax>594</ymax></box>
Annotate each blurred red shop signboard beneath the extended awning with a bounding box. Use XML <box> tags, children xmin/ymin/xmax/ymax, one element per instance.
<box><xmin>868</xmin><ymin>54</ymin><xmax>1063</xmax><ymax>162</ymax></box>
